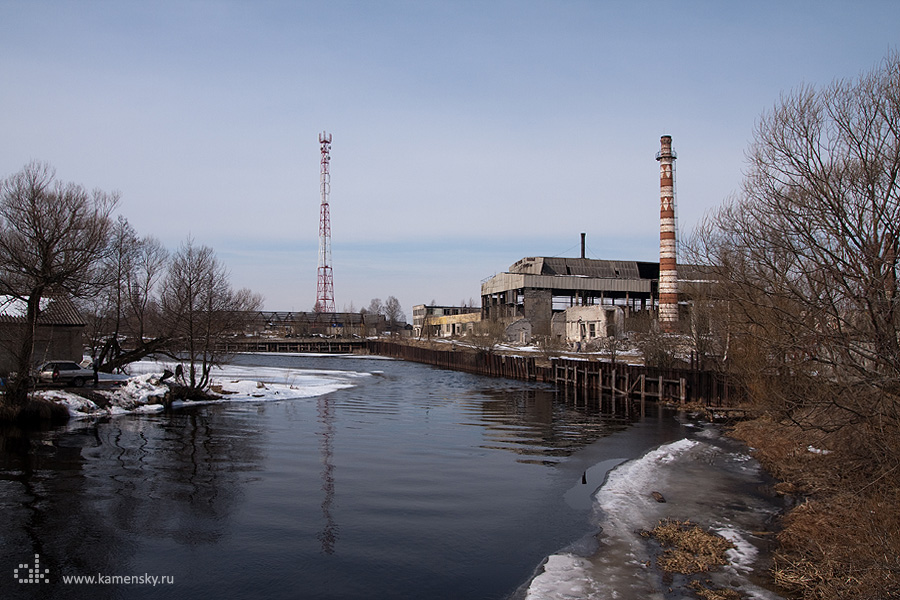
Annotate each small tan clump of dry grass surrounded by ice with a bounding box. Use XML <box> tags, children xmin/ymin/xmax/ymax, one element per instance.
<box><xmin>646</xmin><ymin>519</ymin><xmax>734</xmax><ymax>575</ymax></box>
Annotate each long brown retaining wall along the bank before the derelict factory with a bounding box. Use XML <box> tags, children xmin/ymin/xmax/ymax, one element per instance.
<box><xmin>368</xmin><ymin>340</ymin><xmax>740</xmax><ymax>407</ymax></box>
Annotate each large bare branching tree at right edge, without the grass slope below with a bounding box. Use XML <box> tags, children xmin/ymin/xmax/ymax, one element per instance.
<box><xmin>698</xmin><ymin>54</ymin><xmax>900</xmax><ymax>462</ymax></box>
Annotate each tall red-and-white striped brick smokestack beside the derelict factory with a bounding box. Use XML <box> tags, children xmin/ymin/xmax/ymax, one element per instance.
<box><xmin>656</xmin><ymin>135</ymin><xmax>678</xmax><ymax>331</ymax></box>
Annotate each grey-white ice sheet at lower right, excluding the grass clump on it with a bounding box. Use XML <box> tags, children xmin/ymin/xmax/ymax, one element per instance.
<box><xmin>525</xmin><ymin>428</ymin><xmax>779</xmax><ymax>600</ymax></box>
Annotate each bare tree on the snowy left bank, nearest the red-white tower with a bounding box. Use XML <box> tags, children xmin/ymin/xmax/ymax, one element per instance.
<box><xmin>160</xmin><ymin>239</ymin><xmax>262</xmax><ymax>392</ymax></box>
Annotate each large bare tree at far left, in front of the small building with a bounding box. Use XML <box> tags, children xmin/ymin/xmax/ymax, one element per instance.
<box><xmin>0</xmin><ymin>162</ymin><xmax>118</xmax><ymax>405</ymax></box>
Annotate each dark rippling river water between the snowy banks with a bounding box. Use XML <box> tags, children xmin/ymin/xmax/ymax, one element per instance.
<box><xmin>0</xmin><ymin>355</ymin><xmax>780</xmax><ymax>600</ymax></box>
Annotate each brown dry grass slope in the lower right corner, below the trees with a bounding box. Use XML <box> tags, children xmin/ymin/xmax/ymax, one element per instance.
<box><xmin>734</xmin><ymin>419</ymin><xmax>900</xmax><ymax>600</ymax></box>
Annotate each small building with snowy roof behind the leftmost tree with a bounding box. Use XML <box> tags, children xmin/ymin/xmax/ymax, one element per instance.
<box><xmin>0</xmin><ymin>296</ymin><xmax>85</xmax><ymax>374</ymax></box>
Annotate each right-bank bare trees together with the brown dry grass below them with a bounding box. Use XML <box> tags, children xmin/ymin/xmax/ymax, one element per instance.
<box><xmin>687</xmin><ymin>53</ymin><xmax>900</xmax><ymax>599</ymax></box>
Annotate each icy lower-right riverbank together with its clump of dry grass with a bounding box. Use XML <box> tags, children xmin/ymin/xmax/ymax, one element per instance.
<box><xmin>518</xmin><ymin>423</ymin><xmax>782</xmax><ymax>600</ymax></box>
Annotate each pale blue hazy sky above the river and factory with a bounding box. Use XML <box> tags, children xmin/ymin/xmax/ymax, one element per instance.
<box><xmin>0</xmin><ymin>0</ymin><xmax>900</xmax><ymax>319</ymax></box>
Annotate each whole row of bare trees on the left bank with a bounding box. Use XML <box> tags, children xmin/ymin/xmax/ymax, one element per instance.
<box><xmin>0</xmin><ymin>162</ymin><xmax>262</xmax><ymax>407</ymax></box>
